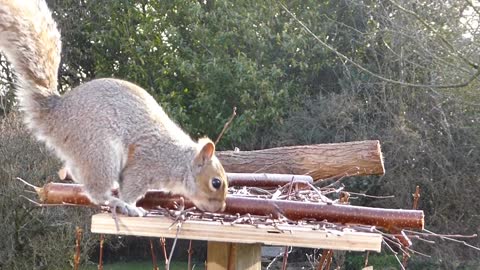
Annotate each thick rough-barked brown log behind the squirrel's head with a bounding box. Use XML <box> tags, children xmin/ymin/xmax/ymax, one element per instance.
<box><xmin>217</xmin><ymin>140</ymin><xmax>385</xmax><ymax>180</ymax></box>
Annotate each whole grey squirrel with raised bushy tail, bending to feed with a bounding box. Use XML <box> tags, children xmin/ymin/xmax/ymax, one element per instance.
<box><xmin>0</xmin><ymin>0</ymin><xmax>228</xmax><ymax>216</ymax></box>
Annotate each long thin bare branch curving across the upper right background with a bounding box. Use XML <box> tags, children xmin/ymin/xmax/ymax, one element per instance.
<box><xmin>279</xmin><ymin>2</ymin><xmax>480</xmax><ymax>88</ymax></box>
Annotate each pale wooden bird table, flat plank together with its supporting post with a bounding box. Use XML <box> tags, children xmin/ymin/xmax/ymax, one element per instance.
<box><xmin>91</xmin><ymin>213</ymin><xmax>382</xmax><ymax>270</ymax></box>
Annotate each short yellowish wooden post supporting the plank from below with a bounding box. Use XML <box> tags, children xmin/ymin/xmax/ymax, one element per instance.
<box><xmin>207</xmin><ymin>241</ymin><xmax>262</xmax><ymax>270</ymax></box>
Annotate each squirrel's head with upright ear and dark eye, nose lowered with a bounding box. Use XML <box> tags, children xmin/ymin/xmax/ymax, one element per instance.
<box><xmin>189</xmin><ymin>138</ymin><xmax>228</xmax><ymax>212</ymax></box>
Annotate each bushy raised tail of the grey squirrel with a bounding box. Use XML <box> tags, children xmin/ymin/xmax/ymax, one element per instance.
<box><xmin>0</xmin><ymin>0</ymin><xmax>61</xmax><ymax>130</ymax></box>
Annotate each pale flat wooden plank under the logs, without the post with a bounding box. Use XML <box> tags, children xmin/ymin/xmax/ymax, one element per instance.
<box><xmin>91</xmin><ymin>213</ymin><xmax>382</xmax><ymax>252</ymax></box>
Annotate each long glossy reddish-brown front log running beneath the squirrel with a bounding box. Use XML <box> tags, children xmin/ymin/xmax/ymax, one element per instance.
<box><xmin>37</xmin><ymin>183</ymin><xmax>424</xmax><ymax>230</ymax></box>
